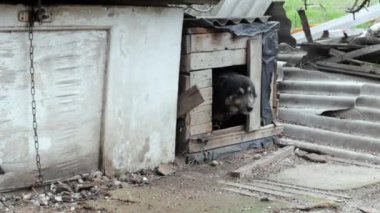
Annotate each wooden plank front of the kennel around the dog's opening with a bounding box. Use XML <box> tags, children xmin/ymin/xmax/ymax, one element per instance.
<box><xmin>177</xmin><ymin>28</ymin><xmax>282</xmax><ymax>153</ymax></box>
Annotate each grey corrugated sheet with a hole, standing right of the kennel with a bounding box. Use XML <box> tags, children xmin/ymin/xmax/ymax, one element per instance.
<box><xmin>279</xmin><ymin>67</ymin><xmax>380</xmax><ymax>159</ymax></box>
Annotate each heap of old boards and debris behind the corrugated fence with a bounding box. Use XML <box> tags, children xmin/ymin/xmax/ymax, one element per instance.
<box><xmin>290</xmin><ymin>23</ymin><xmax>380</xmax><ymax>72</ymax></box>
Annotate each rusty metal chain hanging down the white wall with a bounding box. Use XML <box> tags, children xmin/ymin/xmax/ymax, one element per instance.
<box><xmin>29</xmin><ymin>7</ymin><xmax>44</xmax><ymax>185</ymax></box>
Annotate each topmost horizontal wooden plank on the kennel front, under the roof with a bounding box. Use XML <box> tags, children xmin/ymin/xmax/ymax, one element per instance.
<box><xmin>185</xmin><ymin>32</ymin><xmax>249</xmax><ymax>54</ymax></box>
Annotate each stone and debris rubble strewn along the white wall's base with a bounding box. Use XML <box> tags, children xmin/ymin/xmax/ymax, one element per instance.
<box><xmin>0</xmin><ymin>170</ymin><xmax>160</xmax><ymax>212</ymax></box>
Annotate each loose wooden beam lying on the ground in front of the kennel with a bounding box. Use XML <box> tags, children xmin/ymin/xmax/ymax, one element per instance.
<box><xmin>231</xmin><ymin>146</ymin><xmax>294</xmax><ymax>178</ymax></box>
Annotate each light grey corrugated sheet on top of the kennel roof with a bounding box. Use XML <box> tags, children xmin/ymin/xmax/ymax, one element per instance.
<box><xmin>186</xmin><ymin>0</ymin><xmax>272</xmax><ymax>18</ymax></box>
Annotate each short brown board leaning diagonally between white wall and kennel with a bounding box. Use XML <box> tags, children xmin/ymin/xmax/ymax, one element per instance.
<box><xmin>177</xmin><ymin>86</ymin><xmax>205</xmax><ymax>118</ymax></box>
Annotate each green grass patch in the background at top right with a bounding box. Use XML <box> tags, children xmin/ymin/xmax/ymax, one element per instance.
<box><xmin>285</xmin><ymin>0</ymin><xmax>379</xmax><ymax>29</ymax></box>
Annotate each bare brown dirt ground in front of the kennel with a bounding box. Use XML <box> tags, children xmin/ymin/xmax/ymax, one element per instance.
<box><xmin>3</xmin><ymin>148</ymin><xmax>380</xmax><ymax>213</ymax></box>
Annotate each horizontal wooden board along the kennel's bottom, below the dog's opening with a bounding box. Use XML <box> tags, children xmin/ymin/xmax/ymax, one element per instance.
<box><xmin>189</xmin><ymin>125</ymin><xmax>284</xmax><ymax>153</ymax></box>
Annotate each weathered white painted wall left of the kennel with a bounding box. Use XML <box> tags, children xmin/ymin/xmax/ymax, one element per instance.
<box><xmin>0</xmin><ymin>5</ymin><xmax>183</xmax><ymax>189</ymax></box>
